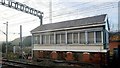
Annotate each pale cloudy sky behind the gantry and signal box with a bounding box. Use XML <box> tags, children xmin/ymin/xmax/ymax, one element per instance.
<box><xmin>0</xmin><ymin>0</ymin><xmax>119</xmax><ymax>41</ymax></box>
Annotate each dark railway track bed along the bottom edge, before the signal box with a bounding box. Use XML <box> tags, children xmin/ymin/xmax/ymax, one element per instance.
<box><xmin>2</xmin><ymin>59</ymin><xmax>100</xmax><ymax>68</ymax></box>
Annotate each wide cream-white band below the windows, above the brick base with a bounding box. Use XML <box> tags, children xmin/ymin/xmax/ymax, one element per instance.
<box><xmin>33</xmin><ymin>45</ymin><xmax>107</xmax><ymax>52</ymax></box>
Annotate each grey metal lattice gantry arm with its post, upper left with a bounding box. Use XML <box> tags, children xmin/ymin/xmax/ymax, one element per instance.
<box><xmin>0</xmin><ymin>0</ymin><xmax>43</xmax><ymax>25</ymax></box>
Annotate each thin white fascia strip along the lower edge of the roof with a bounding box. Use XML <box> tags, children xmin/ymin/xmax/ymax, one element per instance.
<box><xmin>31</xmin><ymin>23</ymin><xmax>105</xmax><ymax>33</ymax></box>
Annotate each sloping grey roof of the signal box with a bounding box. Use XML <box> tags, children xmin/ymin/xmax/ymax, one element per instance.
<box><xmin>31</xmin><ymin>14</ymin><xmax>106</xmax><ymax>32</ymax></box>
